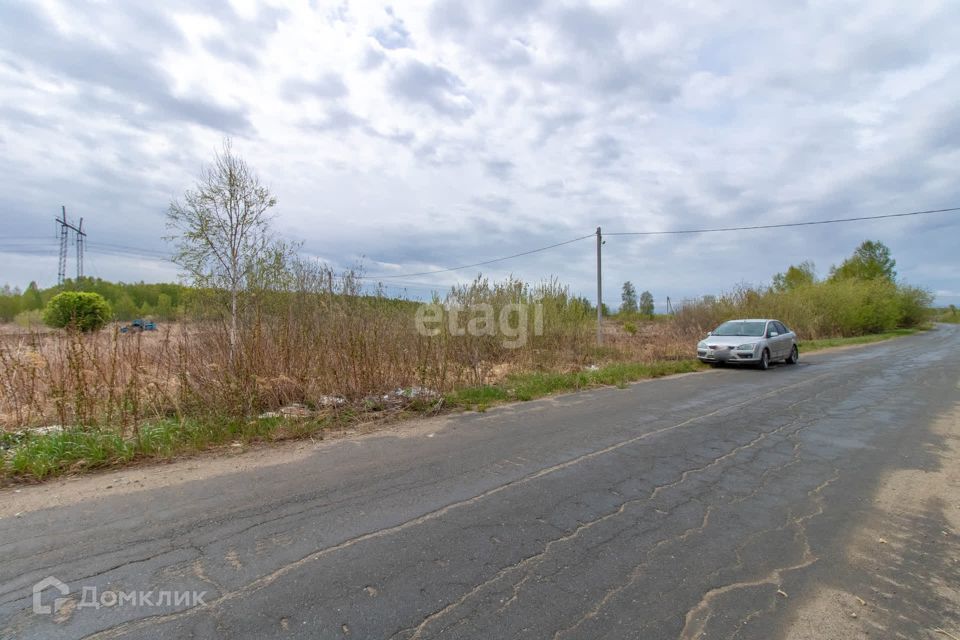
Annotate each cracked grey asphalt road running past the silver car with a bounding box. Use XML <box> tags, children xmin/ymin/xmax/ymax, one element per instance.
<box><xmin>0</xmin><ymin>326</ymin><xmax>960</xmax><ymax>639</ymax></box>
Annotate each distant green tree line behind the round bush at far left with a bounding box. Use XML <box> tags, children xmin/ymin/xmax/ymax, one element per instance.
<box><xmin>0</xmin><ymin>278</ymin><xmax>190</xmax><ymax>324</ymax></box>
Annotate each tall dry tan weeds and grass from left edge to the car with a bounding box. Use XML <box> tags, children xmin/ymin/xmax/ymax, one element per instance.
<box><xmin>0</xmin><ymin>318</ymin><xmax>691</xmax><ymax>436</ymax></box>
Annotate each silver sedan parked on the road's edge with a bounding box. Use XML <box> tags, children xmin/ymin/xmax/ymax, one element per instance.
<box><xmin>697</xmin><ymin>318</ymin><xmax>800</xmax><ymax>369</ymax></box>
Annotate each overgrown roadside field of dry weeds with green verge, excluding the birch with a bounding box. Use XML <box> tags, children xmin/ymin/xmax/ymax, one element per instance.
<box><xmin>0</xmin><ymin>274</ymin><xmax>927</xmax><ymax>478</ymax></box>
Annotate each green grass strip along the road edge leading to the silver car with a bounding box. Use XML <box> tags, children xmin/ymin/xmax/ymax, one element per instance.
<box><xmin>444</xmin><ymin>359</ymin><xmax>705</xmax><ymax>411</ymax></box>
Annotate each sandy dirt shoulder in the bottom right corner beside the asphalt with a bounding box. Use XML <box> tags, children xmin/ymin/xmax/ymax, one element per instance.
<box><xmin>785</xmin><ymin>404</ymin><xmax>960</xmax><ymax>640</ymax></box>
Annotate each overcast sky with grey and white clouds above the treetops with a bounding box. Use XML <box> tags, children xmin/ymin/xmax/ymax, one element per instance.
<box><xmin>0</xmin><ymin>0</ymin><xmax>960</xmax><ymax>306</ymax></box>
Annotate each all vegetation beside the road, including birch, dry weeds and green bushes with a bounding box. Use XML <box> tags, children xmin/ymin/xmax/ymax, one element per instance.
<box><xmin>0</xmin><ymin>145</ymin><xmax>932</xmax><ymax>480</ymax></box>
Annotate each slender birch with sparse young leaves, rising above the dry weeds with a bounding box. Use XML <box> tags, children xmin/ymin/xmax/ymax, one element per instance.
<box><xmin>167</xmin><ymin>139</ymin><xmax>277</xmax><ymax>362</ymax></box>
